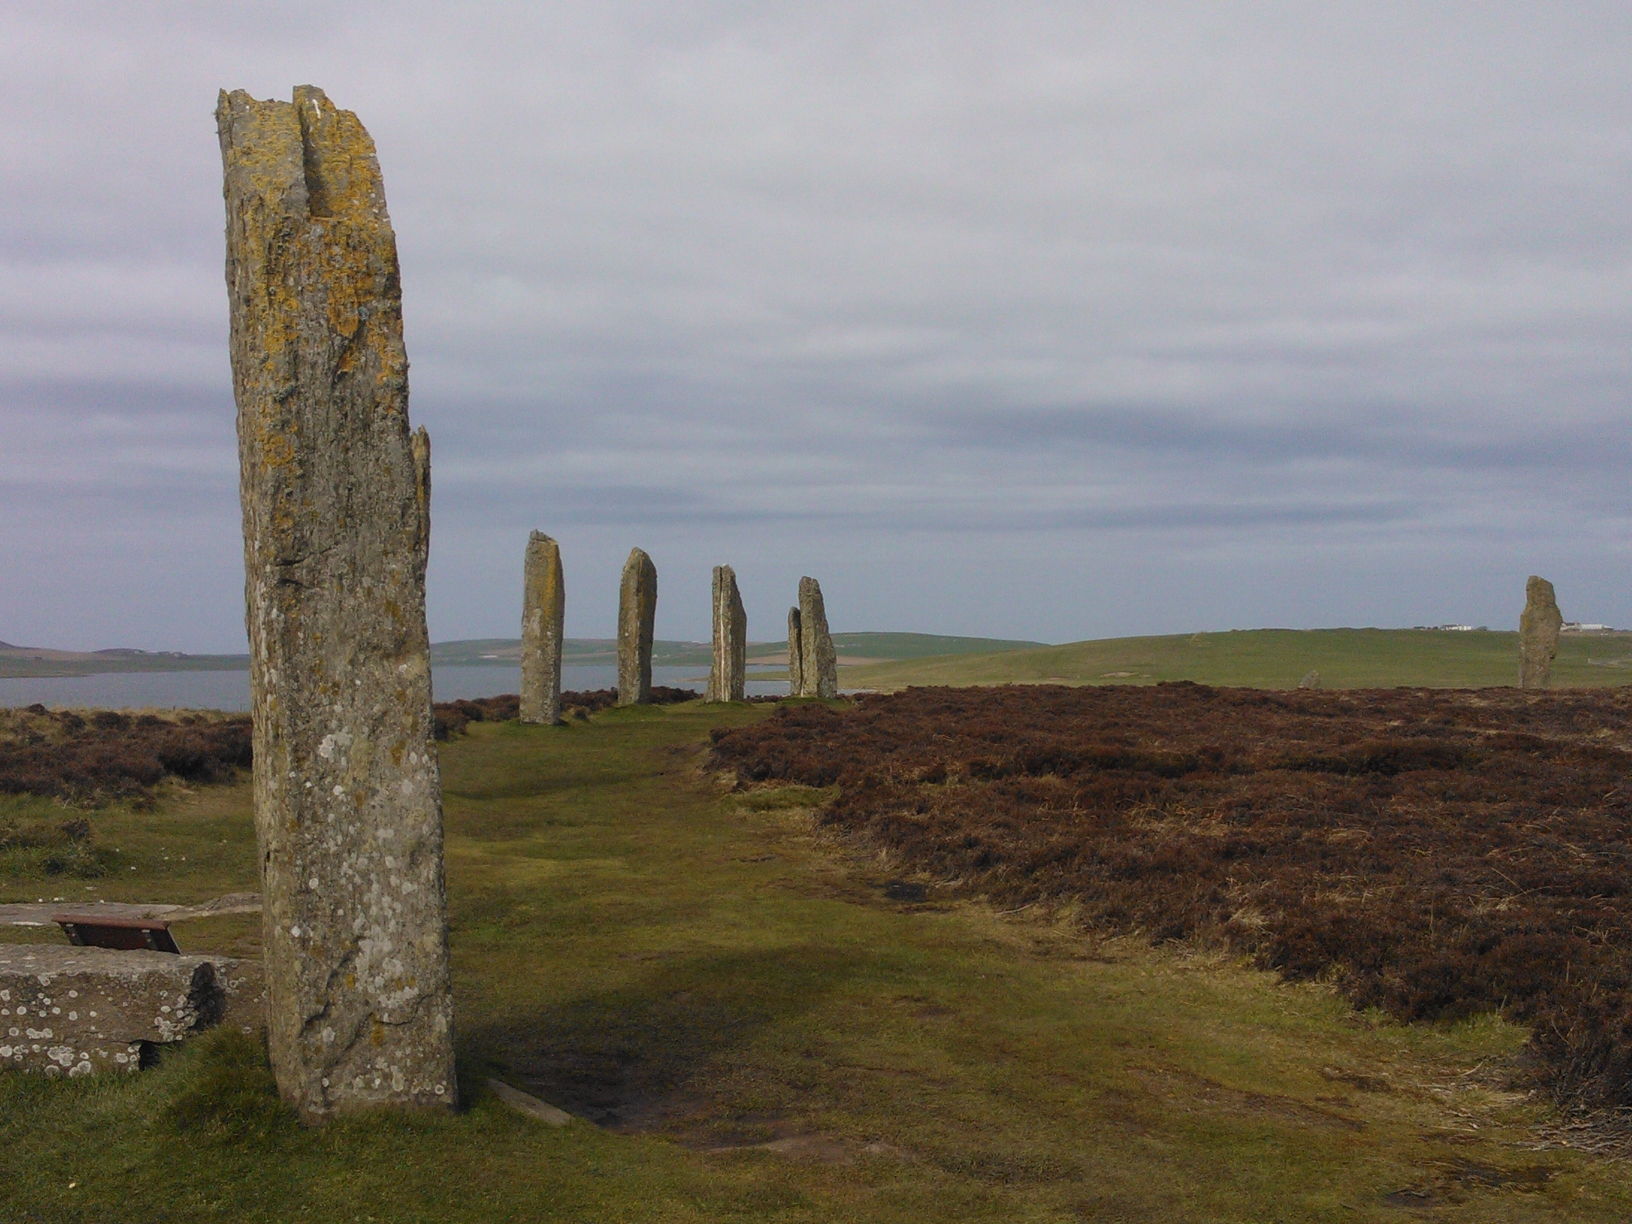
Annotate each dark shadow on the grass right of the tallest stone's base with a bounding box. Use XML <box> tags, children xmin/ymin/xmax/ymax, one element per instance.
<box><xmin>460</xmin><ymin>945</ymin><xmax>862</xmax><ymax>1133</ymax></box>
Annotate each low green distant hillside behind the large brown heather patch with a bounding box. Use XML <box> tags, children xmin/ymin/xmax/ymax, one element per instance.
<box><xmin>839</xmin><ymin>628</ymin><xmax>1632</xmax><ymax>690</ymax></box>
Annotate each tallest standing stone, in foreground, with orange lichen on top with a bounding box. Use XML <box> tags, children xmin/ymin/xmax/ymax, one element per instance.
<box><xmin>215</xmin><ymin>85</ymin><xmax>455</xmax><ymax>1120</ymax></box>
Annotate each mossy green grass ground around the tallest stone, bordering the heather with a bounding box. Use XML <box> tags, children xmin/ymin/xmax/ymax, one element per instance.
<box><xmin>0</xmin><ymin>705</ymin><xmax>1632</xmax><ymax>1224</ymax></box>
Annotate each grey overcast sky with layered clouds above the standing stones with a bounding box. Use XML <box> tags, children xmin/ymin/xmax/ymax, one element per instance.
<box><xmin>0</xmin><ymin>0</ymin><xmax>1632</xmax><ymax>650</ymax></box>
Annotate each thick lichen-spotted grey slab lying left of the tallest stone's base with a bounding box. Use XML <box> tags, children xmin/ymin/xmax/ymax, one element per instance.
<box><xmin>0</xmin><ymin>943</ymin><xmax>245</xmax><ymax>1075</ymax></box>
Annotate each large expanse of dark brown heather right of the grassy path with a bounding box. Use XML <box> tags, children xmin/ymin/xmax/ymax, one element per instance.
<box><xmin>713</xmin><ymin>684</ymin><xmax>1632</xmax><ymax>1108</ymax></box>
